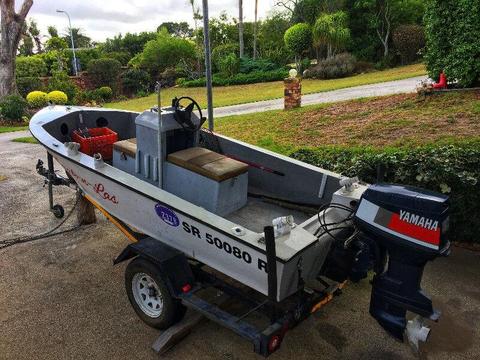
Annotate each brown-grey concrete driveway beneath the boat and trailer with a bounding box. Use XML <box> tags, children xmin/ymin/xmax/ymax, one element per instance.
<box><xmin>0</xmin><ymin>133</ymin><xmax>480</xmax><ymax>360</ymax></box>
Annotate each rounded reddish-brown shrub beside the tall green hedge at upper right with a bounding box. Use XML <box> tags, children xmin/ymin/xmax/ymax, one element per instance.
<box><xmin>392</xmin><ymin>24</ymin><xmax>425</xmax><ymax>64</ymax></box>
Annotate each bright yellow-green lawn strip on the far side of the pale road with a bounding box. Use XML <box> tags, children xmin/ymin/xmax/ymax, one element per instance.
<box><xmin>105</xmin><ymin>64</ymin><xmax>425</xmax><ymax>111</ymax></box>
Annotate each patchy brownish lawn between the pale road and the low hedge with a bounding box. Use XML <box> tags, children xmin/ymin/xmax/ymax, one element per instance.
<box><xmin>215</xmin><ymin>91</ymin><xmax>480</xmax><ymax>154</ymax></box>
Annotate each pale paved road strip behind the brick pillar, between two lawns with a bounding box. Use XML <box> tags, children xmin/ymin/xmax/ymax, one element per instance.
<box><xmin>213</xmin><ymin>76</ymin><xmax>426</xmax><ymax>117</ymax></box>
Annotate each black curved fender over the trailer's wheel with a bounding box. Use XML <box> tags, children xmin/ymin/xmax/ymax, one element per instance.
<box><xmin>113</xmin><ymin>237</ymin><xmax>195</xmax><ymax>297</ymax></box>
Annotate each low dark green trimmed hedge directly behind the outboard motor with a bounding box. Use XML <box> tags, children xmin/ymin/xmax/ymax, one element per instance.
<box><xmin>291</xmin><ymin>140</ymin><xmax>480</xmax><ymax>243</ymax></box>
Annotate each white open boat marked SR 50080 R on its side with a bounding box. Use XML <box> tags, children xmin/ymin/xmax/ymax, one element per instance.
<box><xmin>30</xmin><ymin>96</ymin><xmax>446</xmax><ymax>354</ymax></box>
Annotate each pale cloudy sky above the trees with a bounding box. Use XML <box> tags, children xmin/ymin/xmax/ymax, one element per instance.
<box><xmin>27</xmin><ymin>0</ymin><xmax>275</xmax><ymax>41</ymax></box>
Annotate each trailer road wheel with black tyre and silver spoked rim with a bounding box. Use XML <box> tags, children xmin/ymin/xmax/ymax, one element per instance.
<box><xmin>125</xmin><ymin>257</ymin><xmax>186</xmax><ymax>329</ymax></box>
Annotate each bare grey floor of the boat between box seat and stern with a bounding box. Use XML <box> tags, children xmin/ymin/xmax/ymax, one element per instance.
<box><xmin>225</xmin><ymin>196</ymin><xmax>312</xmax><ymax>233</ymax></box>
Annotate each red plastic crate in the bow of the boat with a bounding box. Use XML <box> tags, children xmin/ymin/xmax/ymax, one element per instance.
<box><xmin>72</xmin><ymin>127</ymin><xmax>118</xmax><ymax>160</ymax></box>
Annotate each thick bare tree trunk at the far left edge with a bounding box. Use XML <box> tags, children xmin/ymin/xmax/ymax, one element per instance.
<box><xmin>0</xmin><ymin>0</ymin><xmax>33</xmax><ymax>99</ymax></box>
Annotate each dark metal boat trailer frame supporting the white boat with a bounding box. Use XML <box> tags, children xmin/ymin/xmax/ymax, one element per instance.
<box><xmin>84</xmin><ymin>195</ymin><xmax>346</xmax><ymax>357</ymax></box>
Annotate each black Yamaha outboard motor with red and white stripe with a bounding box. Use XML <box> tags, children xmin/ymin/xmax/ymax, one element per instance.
<box><xmin>354</xmin><ymin>184</ymin><xmax>450</xmax><ymax>342</ymax></box>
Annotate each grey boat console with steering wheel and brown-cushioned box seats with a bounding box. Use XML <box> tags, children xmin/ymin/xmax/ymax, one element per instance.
<box><xmin>112</xmin><ymin>95</ymin><xmax>248</xmax><ymax>215</ymax></box>
